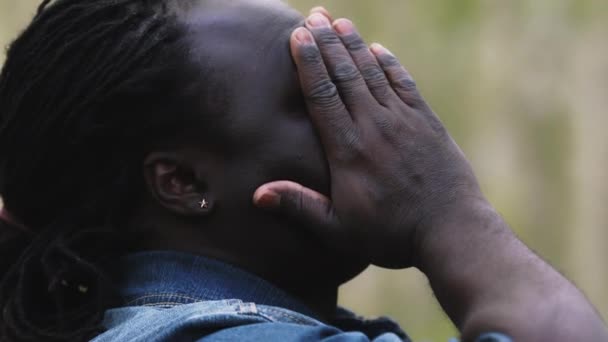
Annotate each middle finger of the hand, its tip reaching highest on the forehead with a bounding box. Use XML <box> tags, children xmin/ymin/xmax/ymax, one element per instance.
<box><xmin>306</xmin><ymin>13</ymin><xmax>374</xmax><ymax>112</ymax></box>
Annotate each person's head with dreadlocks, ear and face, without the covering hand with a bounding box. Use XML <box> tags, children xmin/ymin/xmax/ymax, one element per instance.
<box><xmin>0</xmin><ymin>0</ymin><xmax>366</xmax><ymax>336</ymax></box>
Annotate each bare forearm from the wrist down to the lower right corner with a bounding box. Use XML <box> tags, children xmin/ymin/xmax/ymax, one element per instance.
<box><xmin>418</xmin><ymin>203</ymin><xmax>608</xmax><ymax>341</ymax></box>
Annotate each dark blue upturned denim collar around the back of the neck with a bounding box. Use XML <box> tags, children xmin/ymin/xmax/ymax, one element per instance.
<box><xmin>117</xmin><ymin>251</ymin><xmax>318</xmax><ymax>319</ymax></box>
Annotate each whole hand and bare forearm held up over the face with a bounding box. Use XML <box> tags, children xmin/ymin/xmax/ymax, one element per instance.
<box><xmin>266</xmin><ymin>13</ymin><xmax>606</xmax><ymax>341</ymax></box>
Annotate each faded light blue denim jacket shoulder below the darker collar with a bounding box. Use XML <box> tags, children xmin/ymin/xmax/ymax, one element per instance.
<box><xmin>93</xmin><ymin>300</ymin><xmax>402</xmax><ymax>342</ymax></box>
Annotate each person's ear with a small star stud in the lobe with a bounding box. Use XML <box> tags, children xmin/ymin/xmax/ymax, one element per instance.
<box><xmin>144</xmin><ymin>152</ymin><xmax>214</xmax><ymax>216</ymax></box>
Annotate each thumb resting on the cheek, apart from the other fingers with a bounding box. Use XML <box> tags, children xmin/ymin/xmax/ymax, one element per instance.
<box><xmin>253</xmin><ymin>181</ymin><xmax>339</xmax><ymax>236</ymax></box>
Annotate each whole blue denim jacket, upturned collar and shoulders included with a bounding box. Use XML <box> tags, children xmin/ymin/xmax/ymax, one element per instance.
<box><xmin>93</xmin><ymin>251</ymin><xmax>508</xmax><ymax>342</ymax></box>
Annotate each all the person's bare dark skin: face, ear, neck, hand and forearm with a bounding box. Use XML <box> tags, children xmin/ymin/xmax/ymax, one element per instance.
<box><xmin>128</xmin><ymin>1</ymin><xmax>608</xmax><ymax>341</ymax></box>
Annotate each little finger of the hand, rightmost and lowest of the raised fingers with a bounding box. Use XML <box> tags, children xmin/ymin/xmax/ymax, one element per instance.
<box><xmin>370</xmin><ymin>43</ymin><xmax>424</xmax><ymax>108</ymax></box>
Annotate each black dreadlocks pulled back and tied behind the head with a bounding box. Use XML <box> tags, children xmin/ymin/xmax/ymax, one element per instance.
<box><xmin>0</xmin><ymin>0</ymin><xmax>204</xmax><ymax>341</ymax></box>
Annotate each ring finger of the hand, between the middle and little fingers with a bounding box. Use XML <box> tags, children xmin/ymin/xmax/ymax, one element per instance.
<box><xmin>333</xmin><ymin>19</ymin><xmax>397</xmax><ymax>106</ymax></box>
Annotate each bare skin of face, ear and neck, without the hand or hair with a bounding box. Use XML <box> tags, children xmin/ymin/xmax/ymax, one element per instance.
<box><xmin>131</xmin><ymin>1</ymin><xmax>369</xmax><ymax>318</ymax></box>
